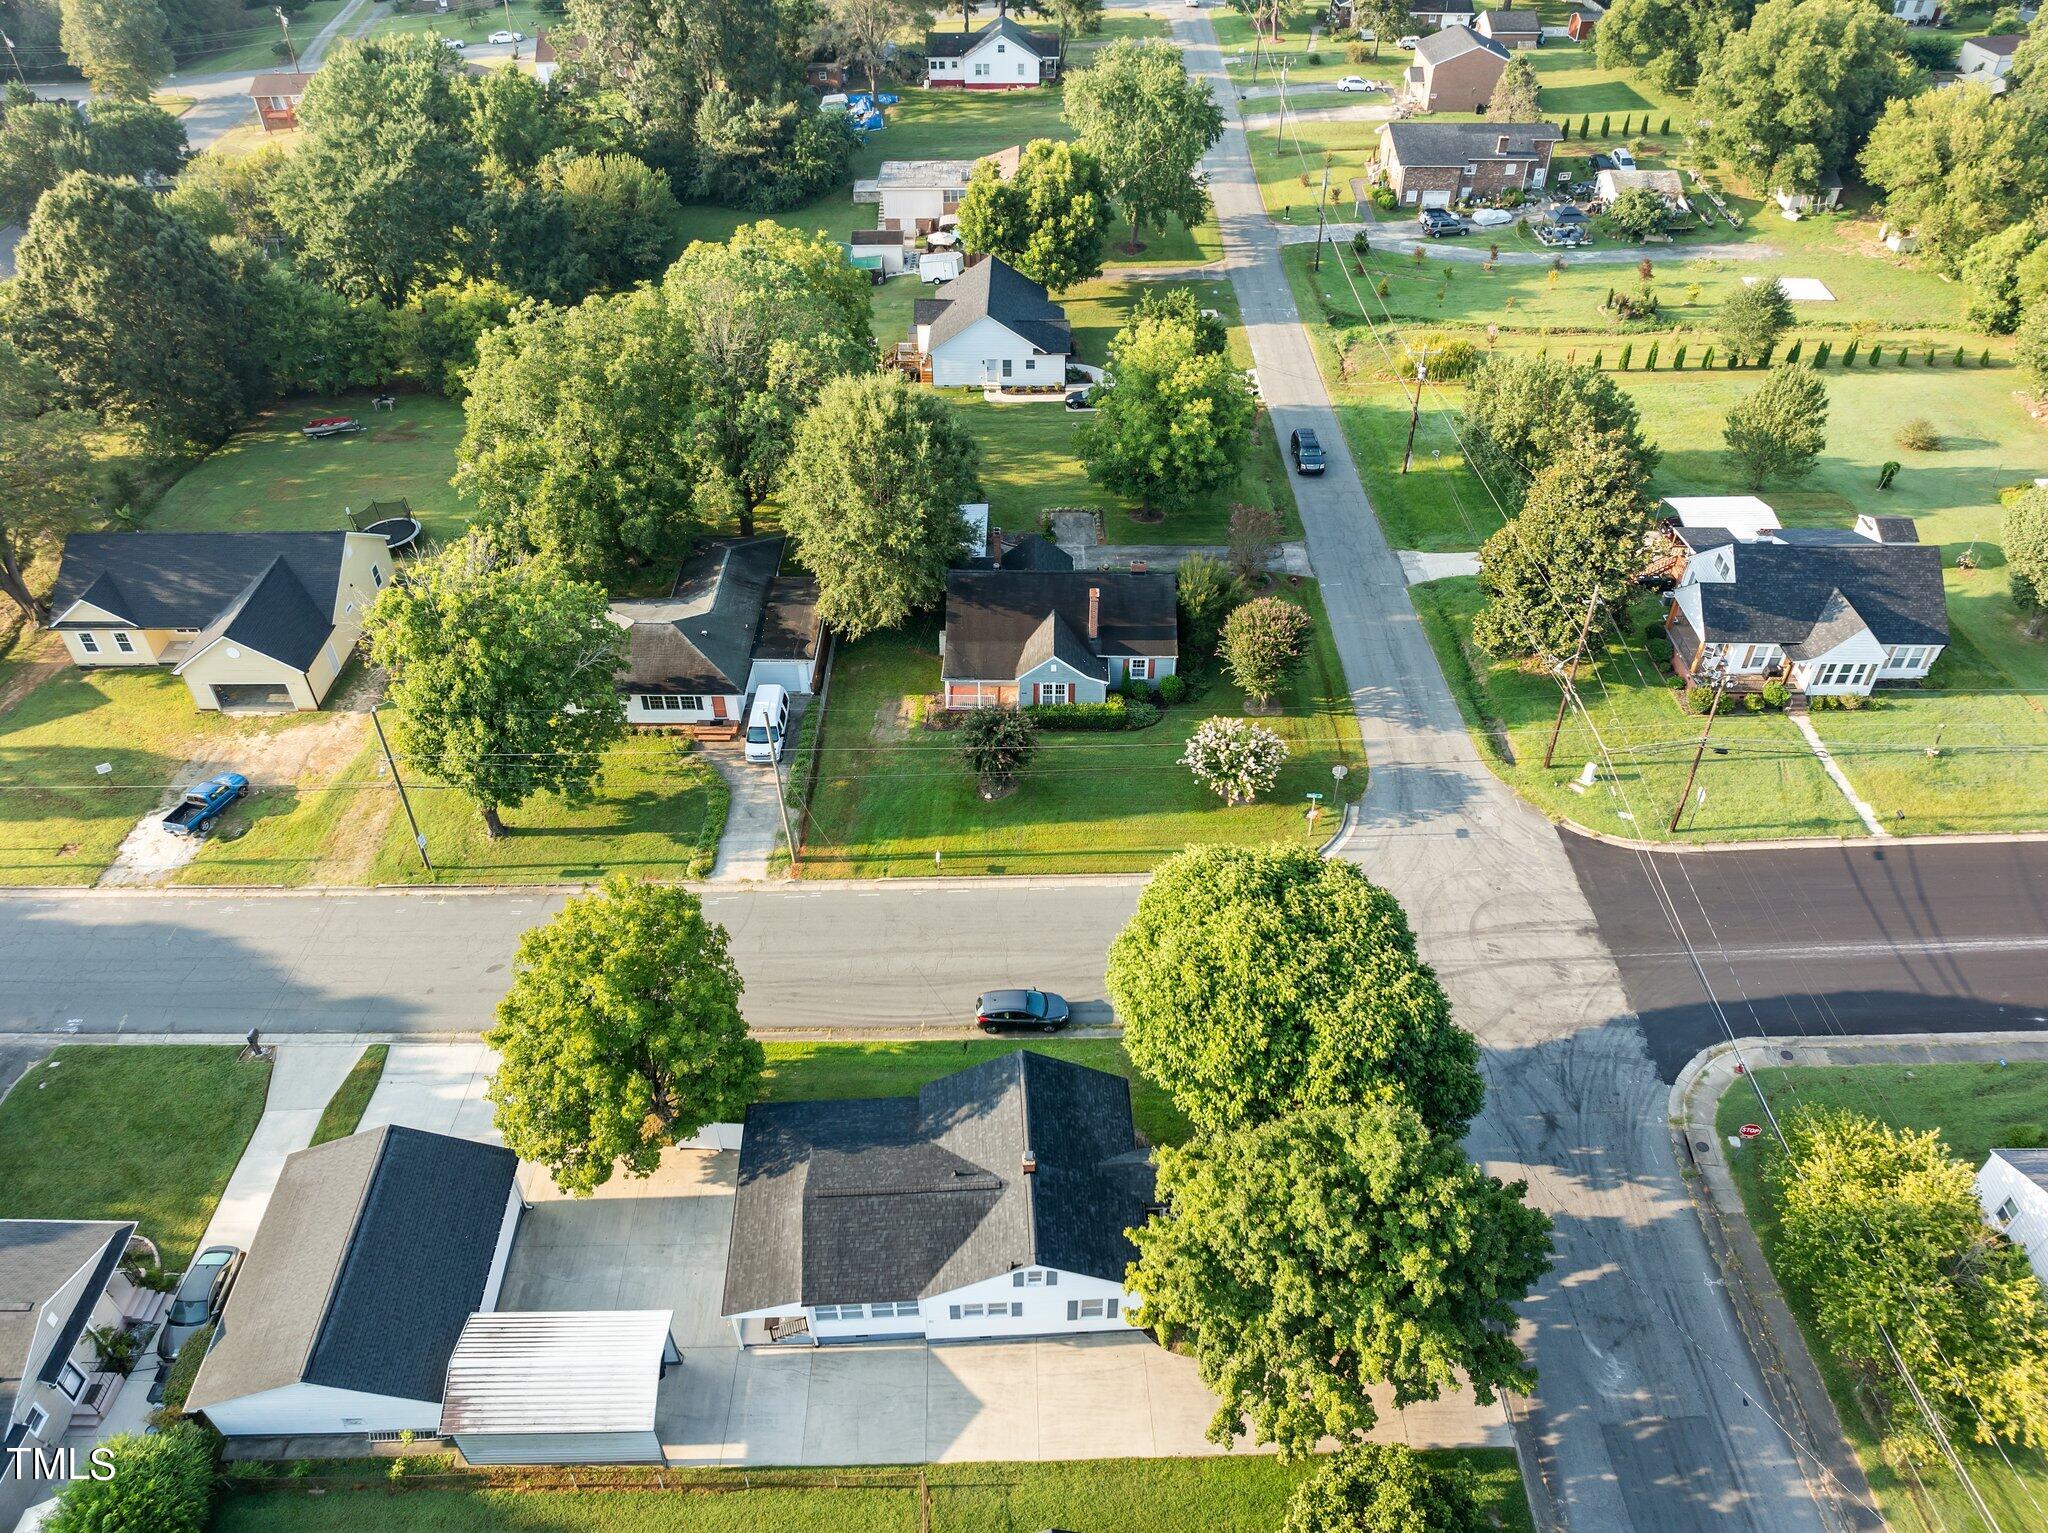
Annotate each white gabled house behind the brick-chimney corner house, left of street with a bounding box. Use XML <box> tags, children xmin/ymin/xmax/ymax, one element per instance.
<box><xmin>897</xmin><ymin>256</ymin><xmax>1073</xmax><ymax>389</ymax></box>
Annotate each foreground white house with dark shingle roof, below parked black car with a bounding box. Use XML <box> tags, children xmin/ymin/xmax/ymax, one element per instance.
<box><xmin>723</xmin><ymin>1050</ymin><xmax>1153</xmax><ymax>1347</ymax></box>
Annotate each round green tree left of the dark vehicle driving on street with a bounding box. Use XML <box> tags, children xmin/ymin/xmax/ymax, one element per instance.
<box><xmin>1077</xmin><ymin>313</ymin><xmax>1257</xmax><ymax>512</ymax></box>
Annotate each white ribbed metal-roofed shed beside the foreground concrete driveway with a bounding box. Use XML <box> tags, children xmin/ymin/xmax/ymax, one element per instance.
<box><xmin>440</xmin><ymin>1310</ymin><xmax>682</xmax><ymax>1463</ymax></box>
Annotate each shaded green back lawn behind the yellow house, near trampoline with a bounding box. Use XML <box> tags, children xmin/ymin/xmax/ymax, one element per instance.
<box><xmin>150</xmin><ymin>393</ymin><xmax>469</xmax><ymax>538</ymax></box>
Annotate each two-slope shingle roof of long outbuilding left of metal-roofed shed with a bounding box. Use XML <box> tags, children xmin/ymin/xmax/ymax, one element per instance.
<box><xmin>188</xmin><ymin>1126</ymin><xmax>518</xmax><ymax>1410</ymax></box>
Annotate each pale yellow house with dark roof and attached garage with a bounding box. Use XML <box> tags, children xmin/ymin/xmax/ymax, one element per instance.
<box><xmin>49</xmin><ymin>532</ymin><xmax>391</xmax><ymax>712</ymax></box>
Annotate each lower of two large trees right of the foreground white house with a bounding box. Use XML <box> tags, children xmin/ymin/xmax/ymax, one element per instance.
<box><xmin>1126</xmin><ymin>1101</ymin><xmax>1550</xmax><ymax>1455</ymax></box>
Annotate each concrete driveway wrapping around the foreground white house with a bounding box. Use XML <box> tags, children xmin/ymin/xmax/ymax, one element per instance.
<box><xmin>498</xmin><ymin>1150</ymin><xmax>1509</xmax><ymax>1465</ymax></box>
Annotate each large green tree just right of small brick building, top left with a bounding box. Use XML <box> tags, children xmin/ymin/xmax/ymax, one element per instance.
<box><xmin>272</xmin><ymin>33</ymin><xmax>479</xmax><ymax>303</ymax></box>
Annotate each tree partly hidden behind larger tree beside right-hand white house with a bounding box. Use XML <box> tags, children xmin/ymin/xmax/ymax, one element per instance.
<box><xmin>1464</xmin><ymin>352</ymin><xmax>1657</xmax><ymax>503</ymax></box>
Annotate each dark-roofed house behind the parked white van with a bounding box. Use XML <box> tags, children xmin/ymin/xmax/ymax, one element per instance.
<box><xmin>610</xmin><ymin>534</ymin><xmax>819</xmax><ymax>727</ymax></box>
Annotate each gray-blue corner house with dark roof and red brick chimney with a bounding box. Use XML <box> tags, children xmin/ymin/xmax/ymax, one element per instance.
<box><xmin>940</xmin><ymin>564</ymin><xmax>1180</xmax><ymax>708</ymax></box>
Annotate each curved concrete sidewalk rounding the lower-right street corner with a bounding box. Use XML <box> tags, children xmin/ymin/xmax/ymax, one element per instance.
<box><xmin>1671</xmin><ymin>1034</ymin><xmax>2048</xmax><ymax>1533</ymax></box>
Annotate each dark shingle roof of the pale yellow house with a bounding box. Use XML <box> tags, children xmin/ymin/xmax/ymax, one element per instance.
<box><xmin>49</xmin><ymin>532</ymin><xmax>365</xmax><ymax>671</ymax></box>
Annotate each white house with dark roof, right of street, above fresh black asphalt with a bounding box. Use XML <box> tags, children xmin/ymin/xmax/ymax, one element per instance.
<box><xmin>1665</xmin><ymin>507</ymin><xmax>1948</xmax><ymax>696</ymax></box>
